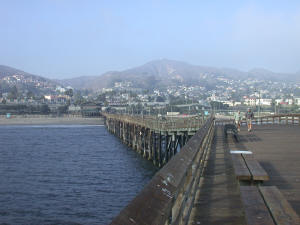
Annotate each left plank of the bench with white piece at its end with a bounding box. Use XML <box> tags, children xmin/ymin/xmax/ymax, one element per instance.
<box><xmin>231</xmin><ymin>154</ymin><xmax>251</xmax><ymax>181</ymax></box>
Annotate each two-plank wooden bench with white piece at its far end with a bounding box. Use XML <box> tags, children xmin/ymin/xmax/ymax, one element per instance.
<box><xmin>231</xmin><ymin>151</ymin><xmax>269</xmax><ymax>184</ymax></box>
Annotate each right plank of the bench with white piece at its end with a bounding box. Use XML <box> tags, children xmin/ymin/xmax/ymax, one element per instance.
<box><xmin>242</xmin><ymin>154</ymin><xmax>270</xmax><ymax>181</ymax></box>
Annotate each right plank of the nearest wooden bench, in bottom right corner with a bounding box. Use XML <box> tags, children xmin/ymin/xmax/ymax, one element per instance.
<box><xmin>259</xmin><ymin>186</ymin><xmax>300</xmax><ymax>225</ymax></box>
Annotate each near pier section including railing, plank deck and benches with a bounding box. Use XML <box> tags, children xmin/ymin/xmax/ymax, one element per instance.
<box><xmin>111</xmin><ymin>115</ymin><xmax>300</xmax><ymax>225</ymax></box>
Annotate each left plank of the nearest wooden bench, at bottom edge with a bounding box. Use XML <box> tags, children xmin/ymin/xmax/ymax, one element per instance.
<box><xmin>240</xmin><ymin>186</ymin><xmax>274</xmax><ymax>225</ymax></box>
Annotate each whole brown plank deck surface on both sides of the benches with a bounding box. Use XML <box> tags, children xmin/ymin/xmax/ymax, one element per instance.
<box><xmin>189</xmin><ymin>125</ymin><xmax>300</xmax><ymax>225</ymax></box>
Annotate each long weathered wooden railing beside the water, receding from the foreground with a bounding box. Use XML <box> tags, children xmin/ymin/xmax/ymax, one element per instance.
<box><xmin>111</xmin><ymin>118</ymin><xmax>215</xmax><ymax>225</ymax></box>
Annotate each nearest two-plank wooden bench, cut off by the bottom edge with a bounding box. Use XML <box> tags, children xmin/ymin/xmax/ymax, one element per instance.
<box><xmin>240</xmin><ymin>186</ymin><xmax>300</xmax><ymax>225</ymax></box>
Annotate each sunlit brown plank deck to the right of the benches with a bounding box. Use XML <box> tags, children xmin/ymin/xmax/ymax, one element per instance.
<box><xmin>229</xmin><ymin>125</ymin><xmax>300</xmax><ymax>215</ymax></box>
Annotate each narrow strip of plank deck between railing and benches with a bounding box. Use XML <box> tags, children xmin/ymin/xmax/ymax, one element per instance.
<box><xmin>189</xmin><ymin>126</ymin><xmax>246</xmax><ymax>225</ymax></box>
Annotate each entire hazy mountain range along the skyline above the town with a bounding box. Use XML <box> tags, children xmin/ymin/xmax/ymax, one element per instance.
<box><xmin>0</xmin><ymin>59</ymin><xmax>300</xmax><ymax>91</ymax></box>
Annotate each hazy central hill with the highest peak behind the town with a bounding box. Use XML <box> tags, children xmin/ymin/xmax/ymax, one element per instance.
<box><xmin>61</xmin><ymin>59</ymin><xmax>244</xmax><ymax>91</ymax></box>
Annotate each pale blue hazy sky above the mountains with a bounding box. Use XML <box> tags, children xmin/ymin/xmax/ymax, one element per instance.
<box><xmin>0</xmin><ymin>0</ymin><xmax>300</xmax><ymax>78</ymax></box>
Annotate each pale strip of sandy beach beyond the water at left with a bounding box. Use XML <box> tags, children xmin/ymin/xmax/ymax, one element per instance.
<box><xmin>0</xmin><ymin>115</ymin><xmax>104</xmax><ymax>126</ymax></box>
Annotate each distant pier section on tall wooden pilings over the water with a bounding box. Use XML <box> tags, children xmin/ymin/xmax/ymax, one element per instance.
<box><xmin>102</xmin><ymin>113</ymin><xmax>203</xmax><ymax>167</ymax></box>
